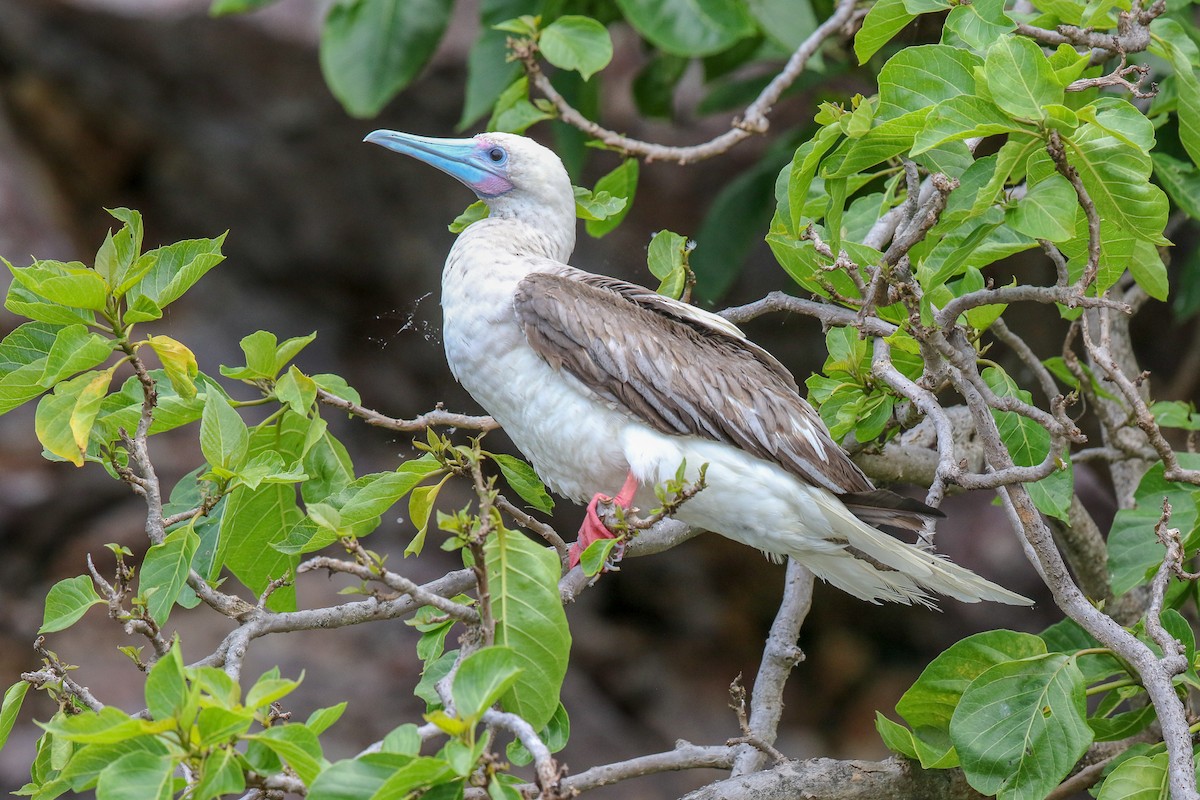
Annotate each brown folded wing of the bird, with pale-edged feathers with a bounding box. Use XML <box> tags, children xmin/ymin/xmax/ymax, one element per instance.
<box><xmin>515</xmin><ymin>269</ymin><xmax>873</xmax><ymax>494</ymax></box>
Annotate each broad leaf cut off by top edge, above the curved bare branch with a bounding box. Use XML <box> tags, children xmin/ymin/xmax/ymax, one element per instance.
<box><xmin>617</xmin><ymin>0</ymin><xmax>756</xmax><ymax>58</ymax></box>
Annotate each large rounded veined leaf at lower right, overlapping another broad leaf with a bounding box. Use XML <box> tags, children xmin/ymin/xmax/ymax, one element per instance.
<box><xmin>950</xmin><ymin>652</ymin><xmax>1092</xmax><ymax>800</ymax></box>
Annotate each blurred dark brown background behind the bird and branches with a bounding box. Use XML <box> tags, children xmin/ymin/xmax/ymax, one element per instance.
<box><xmin>0</xmin><ymin>0</ymin><xmax>1171</xmax><ymax>799</ymax></box>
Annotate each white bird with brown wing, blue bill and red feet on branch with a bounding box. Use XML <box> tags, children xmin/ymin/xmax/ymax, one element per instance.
<box><xmin>366</xmin><ymin>131</ymin><xmax>1031</xmax><ymax>604</ymax></box>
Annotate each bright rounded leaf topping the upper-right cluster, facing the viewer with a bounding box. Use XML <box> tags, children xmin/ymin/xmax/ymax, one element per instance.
<box><xmin>983</xmin><ymin>36</ymin><xmax>1063</xmax><ymax>120</ymax></box>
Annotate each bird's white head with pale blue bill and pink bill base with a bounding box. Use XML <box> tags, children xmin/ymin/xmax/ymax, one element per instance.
<box><xmin>364</xmin><ymin>130</ymin><xmax>575</xmax><ymax>222</ymax></box>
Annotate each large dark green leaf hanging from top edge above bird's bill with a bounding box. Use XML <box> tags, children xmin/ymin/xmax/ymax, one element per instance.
<box><xmin>320</xmin><ymin>0</ymin><xmax>454</xmax><ymax>119</ymax></box>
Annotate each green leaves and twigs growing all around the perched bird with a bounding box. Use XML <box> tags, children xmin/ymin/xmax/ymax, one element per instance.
<box><xmin>7</xmin><ymin>0</ymin><xmax>1200</xmax><ymax>800</ymax></box>
